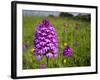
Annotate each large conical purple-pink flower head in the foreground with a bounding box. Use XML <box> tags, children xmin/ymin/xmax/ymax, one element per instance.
<box><xmin>34</xmin><ymin>19</ymin><xmax>58</xmax><ymax>58</ymax></box>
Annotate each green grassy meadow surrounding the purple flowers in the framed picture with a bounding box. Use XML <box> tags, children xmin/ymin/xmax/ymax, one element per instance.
<box><xmin>22</xmin><ymin>16</ymin><xmax>91</xmax><ymax>69</ymax></box>
